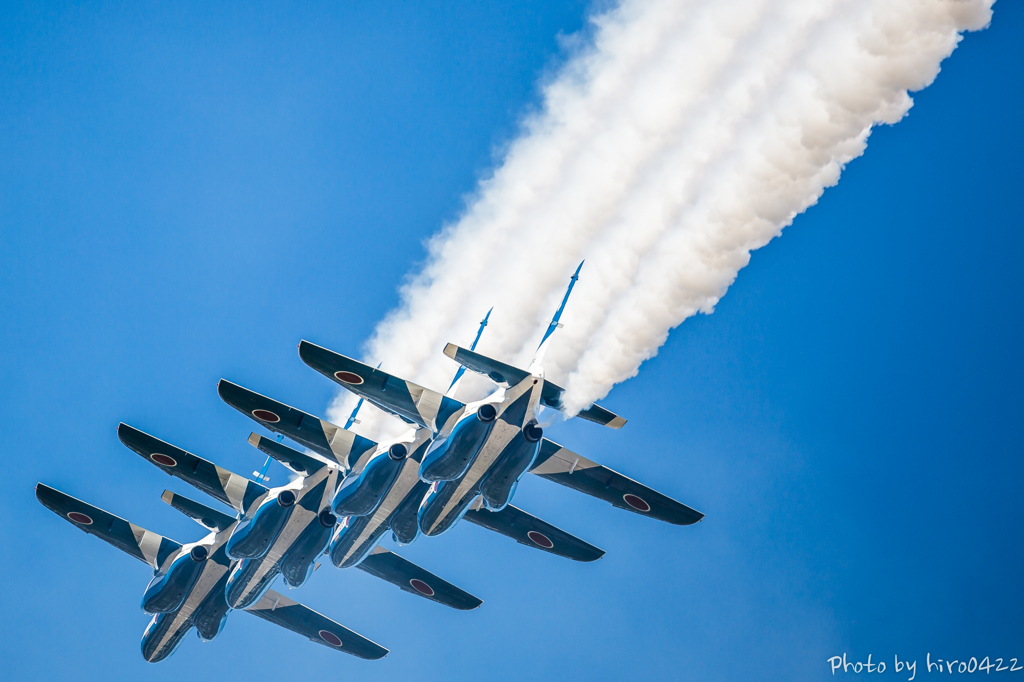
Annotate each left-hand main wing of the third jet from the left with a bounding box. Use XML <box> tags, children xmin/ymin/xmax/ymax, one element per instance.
<box><xmin>217</xmin><ymin>379</ymin><xmax>377</xmax><ymax>469</ymax></box>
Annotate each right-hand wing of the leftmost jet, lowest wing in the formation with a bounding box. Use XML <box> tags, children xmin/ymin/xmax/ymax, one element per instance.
<box><xmin>246</xmin><ymin>590</ymin><xmax>388</xmax><ymax>660</ymax></box>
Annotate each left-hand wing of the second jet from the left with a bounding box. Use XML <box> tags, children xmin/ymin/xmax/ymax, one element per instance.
<box><xmin>118</xmin><ymin>422</ymin><xmax>267</xmax><ymax>514</ymax></box>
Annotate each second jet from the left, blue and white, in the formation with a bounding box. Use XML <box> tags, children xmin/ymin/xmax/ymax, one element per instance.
<box><xmin>118</xmin><ymin>421</ymin><xmax>482</xmax><ymax>609</ymax></box>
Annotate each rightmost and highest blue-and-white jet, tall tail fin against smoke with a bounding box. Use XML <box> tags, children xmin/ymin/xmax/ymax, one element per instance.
<box><xmin>299</xmin><ymin>263</ymin><xmax>703</xmax><ymax>546</ymax></box>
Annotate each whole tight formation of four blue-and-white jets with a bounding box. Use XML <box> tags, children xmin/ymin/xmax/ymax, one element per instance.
<box><xmin>36</xmin><ymin>263</ymin><xmax>703</xmax><ymax>663</ymax></box>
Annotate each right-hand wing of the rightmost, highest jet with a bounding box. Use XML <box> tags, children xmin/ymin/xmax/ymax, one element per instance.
<box><xmin>529</xmin><ymin>438</ymin><xmax>703</xmax><ymax>525</ymax></box>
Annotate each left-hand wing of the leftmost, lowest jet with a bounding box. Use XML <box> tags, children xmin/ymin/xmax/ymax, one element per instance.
<box><xmin>36</xmin><ymin>483</ymin><xmax>181</xmax><ymax>569</ymax></box>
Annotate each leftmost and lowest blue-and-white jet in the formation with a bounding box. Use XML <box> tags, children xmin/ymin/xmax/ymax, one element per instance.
<box><xmin>36</xmin><ymin>483</ymin><xmax>388</xmax><ymax>663</ymax></box>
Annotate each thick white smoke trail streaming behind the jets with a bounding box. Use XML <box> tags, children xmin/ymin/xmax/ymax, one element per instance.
<box><xmin>329</xmin><ymin>0</ymin><xmax>994</xmax><ymax>435</ymax></box>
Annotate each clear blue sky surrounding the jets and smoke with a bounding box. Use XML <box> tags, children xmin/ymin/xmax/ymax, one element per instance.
<box><xmin>0</xmin><ymin>2</ymin><xmax>1024</xmax><ymax>680</ymax></box>
